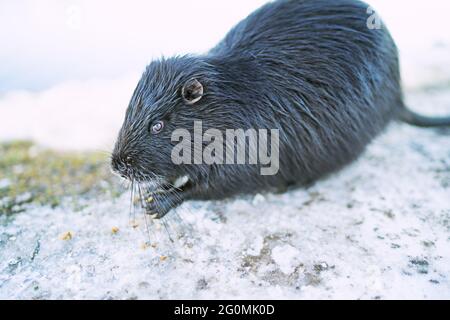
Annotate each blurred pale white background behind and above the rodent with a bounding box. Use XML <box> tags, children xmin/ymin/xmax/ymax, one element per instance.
<box><xmin>0</xmin><ymin>0</ymin><xmax>450</xmax><ymax>150</ymax></box>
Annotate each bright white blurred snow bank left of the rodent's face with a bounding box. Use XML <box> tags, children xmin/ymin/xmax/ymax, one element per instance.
<box><xmin>0</xmin><ymin>75</ymin><xmax>139</xmax><ymax>152</ymax></box>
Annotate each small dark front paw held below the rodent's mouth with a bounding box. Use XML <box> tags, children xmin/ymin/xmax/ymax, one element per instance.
<box><xmin>145</xmin><ymin>191</ymin><xmax>183</xmax><ymax>219</ymax></box>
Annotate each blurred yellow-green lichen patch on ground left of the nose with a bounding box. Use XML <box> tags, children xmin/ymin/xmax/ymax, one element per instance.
<box><xmin>0</xmin><ymin>141</ymin><xmax>121</xmax><ymax>214</ymax></box>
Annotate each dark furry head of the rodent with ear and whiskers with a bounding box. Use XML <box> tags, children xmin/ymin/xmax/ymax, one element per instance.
<box><xmin>111</xmin><ymin>56</ymin><xmax>218</xmax><ymax>188</ymax></box>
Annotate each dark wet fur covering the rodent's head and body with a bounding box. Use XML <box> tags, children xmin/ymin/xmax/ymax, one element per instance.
<box><xmin>113</xmin><ymin>0</ymin><xmax>449</xmax><ymax>216</ymax></box>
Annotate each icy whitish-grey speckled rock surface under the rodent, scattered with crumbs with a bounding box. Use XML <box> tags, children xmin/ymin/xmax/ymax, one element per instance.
<box><xmin>0</xmin><ymin>90</ymin><xmax>450</xmax><ymax>299</ymax></box>
